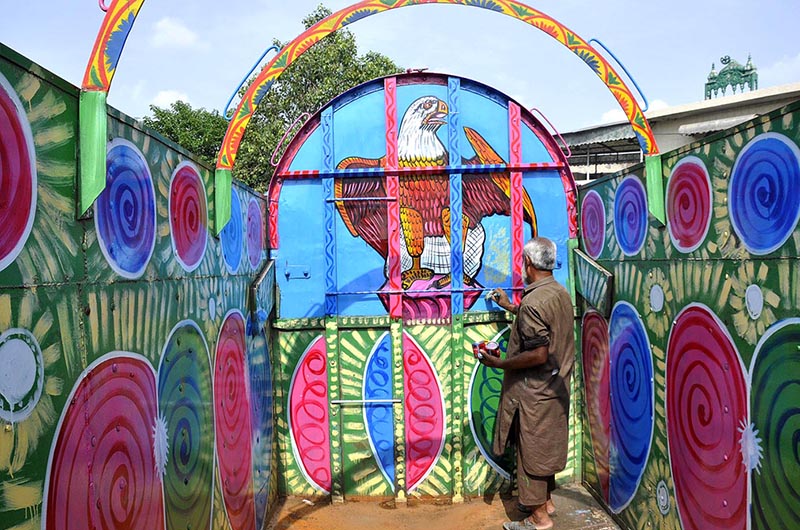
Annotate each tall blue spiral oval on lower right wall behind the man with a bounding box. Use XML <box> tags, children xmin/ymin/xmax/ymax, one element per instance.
<box><xmin>609</xmin><ymin>302</ymin><xmax>653</xmax><ymax>513</ymax></box>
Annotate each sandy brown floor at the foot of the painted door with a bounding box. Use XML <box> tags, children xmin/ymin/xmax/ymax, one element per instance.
<box><xmin>269</xmin><ymin>484</ymin><xmax>619</xmax><ymax>530</ymax></box>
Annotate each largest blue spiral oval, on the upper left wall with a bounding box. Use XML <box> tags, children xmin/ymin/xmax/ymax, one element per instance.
<box><xmin>94</xmin><ymin>139</ymin><xmax>156</xmax><ymax>278</ymax></box>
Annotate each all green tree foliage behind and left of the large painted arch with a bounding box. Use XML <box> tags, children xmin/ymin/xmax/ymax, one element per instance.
<box><xmin>145</xmin><ymin>4</ymin><xmax>402</xmax><ymax>191</ymax></box>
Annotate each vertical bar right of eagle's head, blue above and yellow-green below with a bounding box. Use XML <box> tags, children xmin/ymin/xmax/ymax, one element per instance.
<box><xmin>447</xmin><ymin>77</ymin><xmax>466</xmax><ymax>503</ymax></box>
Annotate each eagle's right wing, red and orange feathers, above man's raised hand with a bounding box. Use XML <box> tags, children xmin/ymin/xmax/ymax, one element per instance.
<box><xmin>462</xmin><ymin>127</ymin><xmax>537</xmax><ymax>236</ymax></box>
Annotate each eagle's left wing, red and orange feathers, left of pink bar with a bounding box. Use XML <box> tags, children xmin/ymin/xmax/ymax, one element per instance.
<box><xmin>334</xmin><ymin>157</ymin><xmax>389</xmax><ymax>259</ymax></box>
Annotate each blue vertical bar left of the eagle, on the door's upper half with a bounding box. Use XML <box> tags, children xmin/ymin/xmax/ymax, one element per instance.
<box><xmin>321</xmin><ymin>107</ymin><xmax>339</xmax><ymax>316</ymax></box>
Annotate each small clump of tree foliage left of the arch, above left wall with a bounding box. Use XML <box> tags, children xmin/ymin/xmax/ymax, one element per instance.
<box><xmin>142</xmin><ymin>101</ymin><xmax>228</xmax><ymax>167</ymax></box>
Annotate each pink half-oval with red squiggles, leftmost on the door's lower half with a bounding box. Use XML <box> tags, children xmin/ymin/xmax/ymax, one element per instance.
<box><xmin>289</xmin><ymin>336</ymin><xmax>331</xmax><ymax>493</ymax></box>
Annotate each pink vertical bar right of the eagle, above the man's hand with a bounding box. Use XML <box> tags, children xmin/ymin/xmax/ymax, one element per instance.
<box><xmin>508</xmin><ymin>101</ymin><xmax>525</xmax><ymax>304</ymax></box>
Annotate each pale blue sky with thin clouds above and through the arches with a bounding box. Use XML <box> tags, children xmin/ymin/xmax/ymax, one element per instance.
<box><xmin>0</xmin><ymin>0</ymin><xmax>800</xmax><ymax>132</ymax></box>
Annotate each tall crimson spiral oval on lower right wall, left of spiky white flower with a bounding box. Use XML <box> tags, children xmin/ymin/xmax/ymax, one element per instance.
<box><xmin>666</xmin><ymin>304</ymin><xmax>748</xmax><ymax>530</ymax></box>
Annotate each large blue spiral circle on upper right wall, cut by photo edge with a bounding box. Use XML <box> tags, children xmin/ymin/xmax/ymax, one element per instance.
<box><xmin>728</xmin><ymin>133</ymin><xmax>800</xmax><ymax>255</ymax></box>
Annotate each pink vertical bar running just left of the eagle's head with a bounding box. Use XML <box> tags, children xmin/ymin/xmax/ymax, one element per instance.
<box><xmin>383</xmin><ymin>77</ymin><xmax>403</xmax><ymax>318</ymax></box>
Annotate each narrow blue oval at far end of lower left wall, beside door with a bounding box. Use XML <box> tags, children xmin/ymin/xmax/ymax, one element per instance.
<box><xmin>247</xmin><ymin>327</ymin><xmax>273</xmax><ymax>528</ymax></box>
